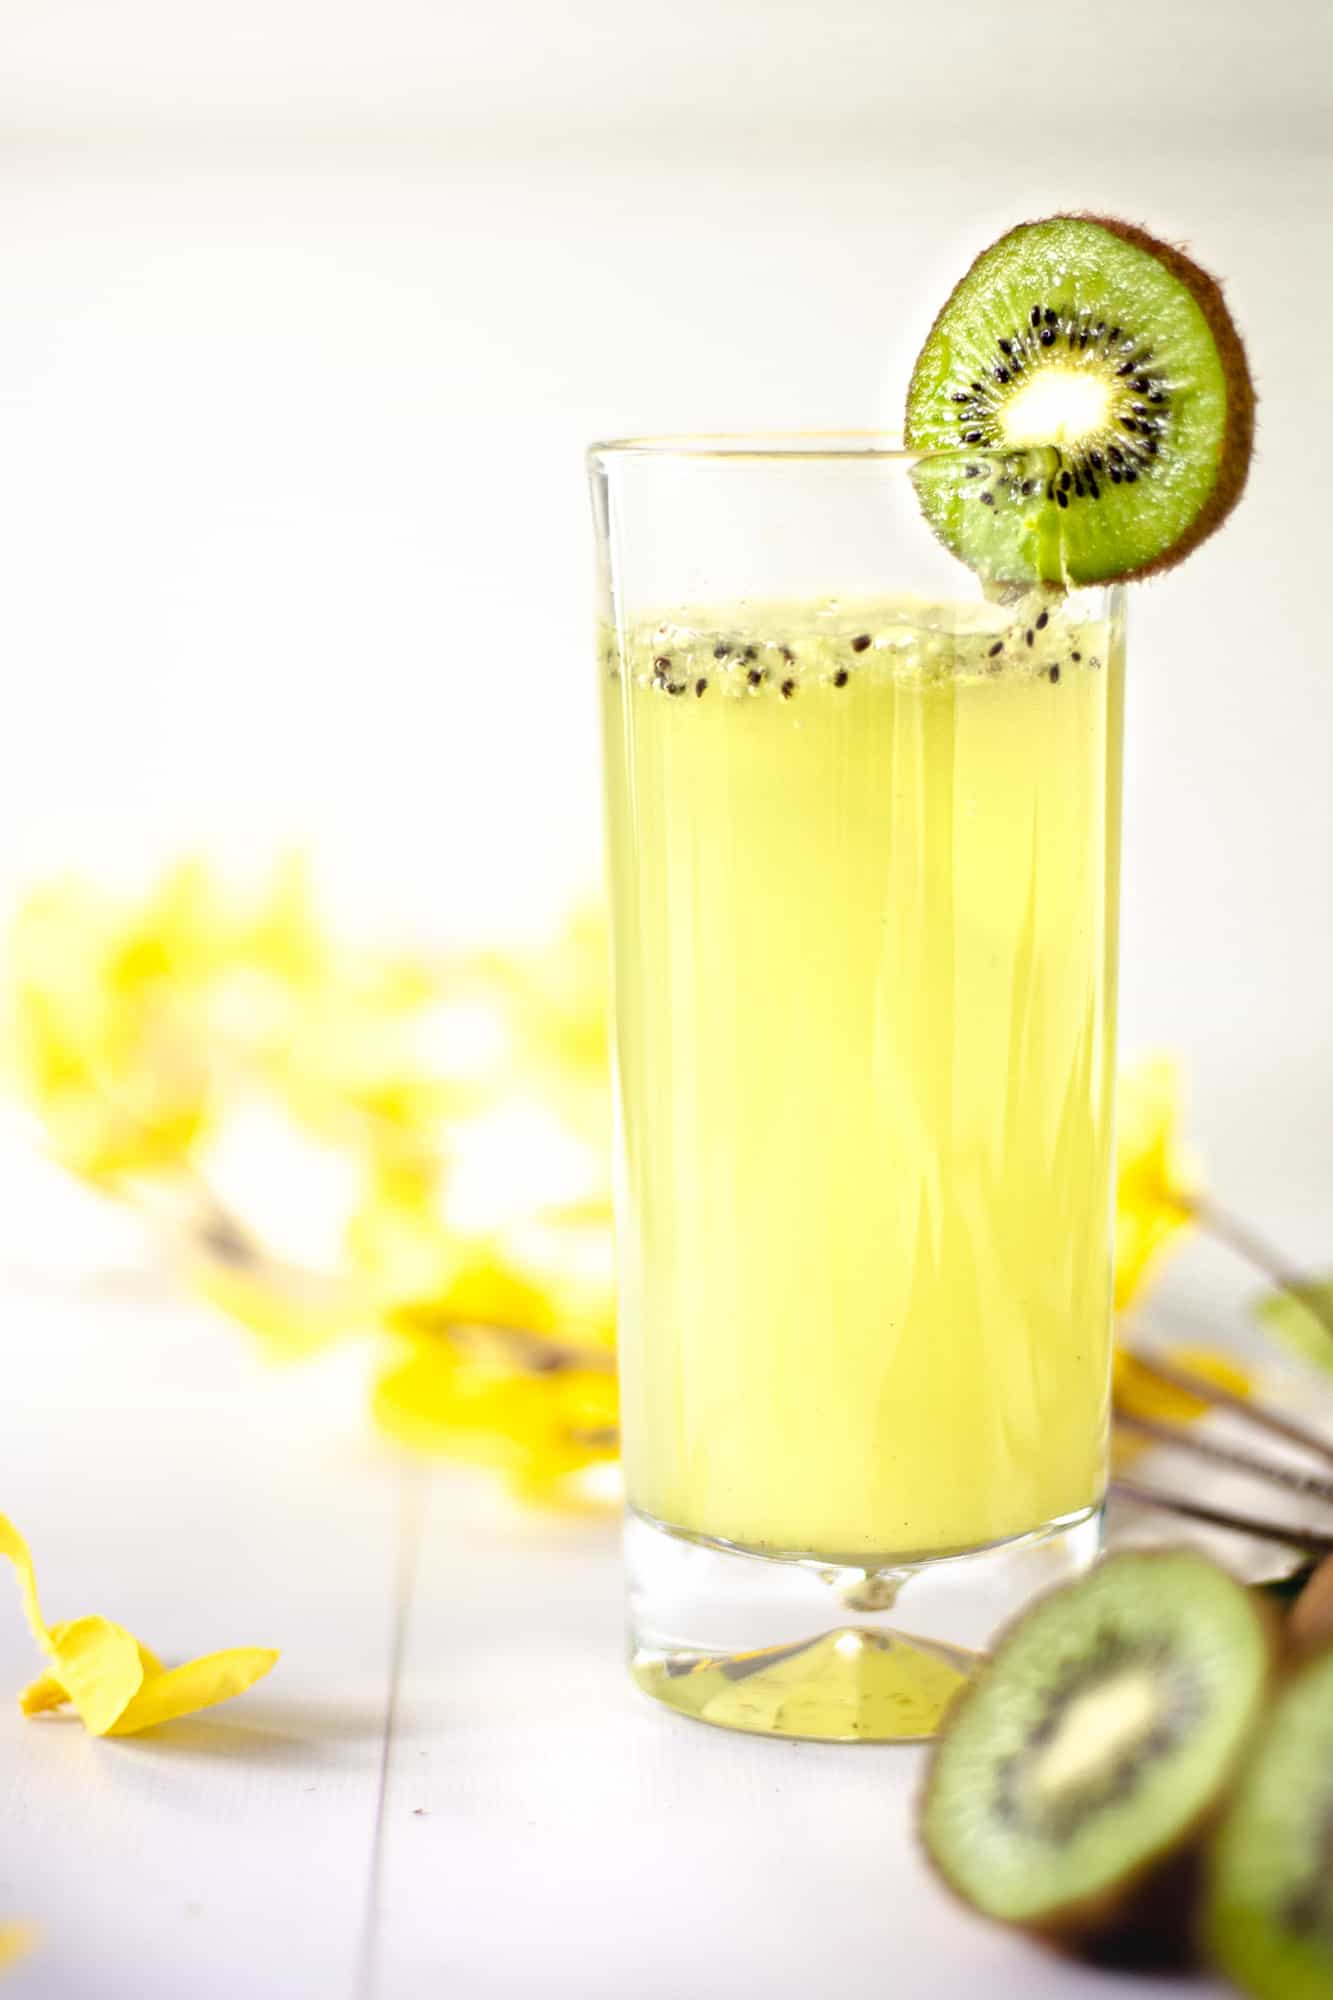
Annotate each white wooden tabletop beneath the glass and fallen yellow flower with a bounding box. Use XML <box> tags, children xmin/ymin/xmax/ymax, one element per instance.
<box><xmin>0</xmin><ymin>1152</ymin><xmax>1248</xmax><ymax>2000</ymax></box>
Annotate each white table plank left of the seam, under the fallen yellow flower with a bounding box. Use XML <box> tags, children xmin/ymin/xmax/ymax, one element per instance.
<box><xmin>0</xmin><ymin>1296</ymin><xmax>398</xmax><ymax>2000</ymax></box>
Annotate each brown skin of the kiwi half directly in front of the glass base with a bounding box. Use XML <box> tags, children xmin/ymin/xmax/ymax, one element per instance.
<box><xmin>917</xmin><ymin>1548</ymin><xmax>1281</xmax><ymax>1972</ymax></box>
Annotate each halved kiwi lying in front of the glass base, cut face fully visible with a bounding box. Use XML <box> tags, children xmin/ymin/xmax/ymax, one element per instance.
<box><xmin>921</xmin><ymin>1550</ymin><xmax>1273</xmax><ymax>1964</ymax></box>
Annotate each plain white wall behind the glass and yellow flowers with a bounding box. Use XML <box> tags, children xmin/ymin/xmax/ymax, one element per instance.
<box><xmin>0</xmin><ymin>0</ymin><xmax>1333</xmax><ymax>1232</ymax></box>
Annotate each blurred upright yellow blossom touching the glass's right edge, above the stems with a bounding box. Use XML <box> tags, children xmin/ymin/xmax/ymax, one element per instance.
<box><xmin>1115</xmin><ymin>1056</ymin><xmax>1199</xmax><ymax>1312</ymax></box>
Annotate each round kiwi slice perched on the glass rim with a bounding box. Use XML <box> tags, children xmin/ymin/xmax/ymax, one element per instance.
<box><xmin>905</xmin><ymin>216</ymin><xmax>1255</xmax><ymax>586</ymax></box>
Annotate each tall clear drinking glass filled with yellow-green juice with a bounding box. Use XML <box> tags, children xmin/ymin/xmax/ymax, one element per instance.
<box><xmin>590</xmin><ymin>436</ymin><xmax>1123</xmax><ymax>1740</ymax></box>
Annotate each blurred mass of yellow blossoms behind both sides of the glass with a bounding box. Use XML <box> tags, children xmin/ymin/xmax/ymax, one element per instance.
<box><xmin>18</xmin><ymin>856</ymin><xmax>1280</xmax><ymax>1498</ymax></box>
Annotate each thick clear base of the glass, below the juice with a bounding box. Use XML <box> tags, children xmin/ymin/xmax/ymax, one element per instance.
<box><xmin>624</xmin><ymin>1508</ymin><xmax>1103</xmax><ymax>1744</ymax></box>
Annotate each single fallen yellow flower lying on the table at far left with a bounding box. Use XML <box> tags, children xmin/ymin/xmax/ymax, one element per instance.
<box><xmin>0</xmin><ymin>1514</ymin><xmax>278</xmax><ymax>1736</ymax></box>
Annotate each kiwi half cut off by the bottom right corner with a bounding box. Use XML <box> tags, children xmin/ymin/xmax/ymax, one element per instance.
<box><xmin>1203</xmin><ymin>1650</ymin><xmax>1333</xmax><ymax>2000</ymax></box>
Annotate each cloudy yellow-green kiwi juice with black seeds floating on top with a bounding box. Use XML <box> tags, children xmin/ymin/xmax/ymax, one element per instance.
<box><xmin>600</xmin><ymin>600</ymin><xmax>1123</xmax><ymax>1562</ymax></box>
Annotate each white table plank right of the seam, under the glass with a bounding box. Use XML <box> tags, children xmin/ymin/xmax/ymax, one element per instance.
<box><xmin>378</xmin><ymin>1484</ymin><xmax>1209</xmax><ymax>2000</ymax></box>
